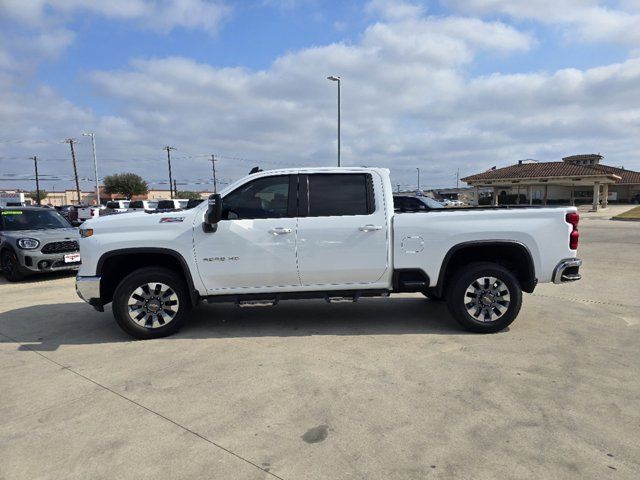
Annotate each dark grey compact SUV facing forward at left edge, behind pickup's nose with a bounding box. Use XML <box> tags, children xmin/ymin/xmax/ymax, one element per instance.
<box><xmin>0</xmin><ymin>207</ymin><xmax>80</xmax><ymax>282</ymax></box>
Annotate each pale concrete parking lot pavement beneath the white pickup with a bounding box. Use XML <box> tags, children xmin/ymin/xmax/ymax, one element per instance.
<box><xmin>0</xmin><ymin>210</ymin><xmax>640</xmax><ymax>479</ymax></box>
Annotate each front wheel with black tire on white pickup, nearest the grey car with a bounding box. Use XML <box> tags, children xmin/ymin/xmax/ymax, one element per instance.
<box><xmin>113</xmin><ymin>267</ymin><xmax>191</xmax><ymax>340</ymax></box>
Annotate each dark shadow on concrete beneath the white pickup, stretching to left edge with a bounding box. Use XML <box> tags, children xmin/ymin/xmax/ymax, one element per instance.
<box><xmin>0</xmin><ymin>297</ymin><xmax>484</xmax><ymax>351</ymax></box>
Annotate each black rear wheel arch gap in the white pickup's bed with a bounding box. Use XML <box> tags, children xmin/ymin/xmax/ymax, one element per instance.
<box><xmin>436</xmin><ymin>240</ymin><xmax>538</xmax><ymax>295</ymax></box>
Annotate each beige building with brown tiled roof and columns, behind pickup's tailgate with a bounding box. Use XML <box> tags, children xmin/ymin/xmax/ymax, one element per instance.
<box><xmin>462</xmin><ymin>154</ymin><xmax>640</xmax><ymax>209</ymax></box>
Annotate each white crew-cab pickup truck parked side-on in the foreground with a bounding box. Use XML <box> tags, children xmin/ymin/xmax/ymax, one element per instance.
<box><xmin>76</xmin><ymin>167</ymin><xmax>582</xmax><ymax>338</ymax></box>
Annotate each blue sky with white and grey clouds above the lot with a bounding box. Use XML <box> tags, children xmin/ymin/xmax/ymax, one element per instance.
<box><xmin>0</xmin><ymin>0</ymin><xmax>640</xmax><ymax>190</ymax></box>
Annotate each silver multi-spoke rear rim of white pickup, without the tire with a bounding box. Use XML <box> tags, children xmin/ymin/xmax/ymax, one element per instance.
<box><xmin>464</xmin><ymin>277</ymin><xmax>511</xmax><ymax>322</ymax></box>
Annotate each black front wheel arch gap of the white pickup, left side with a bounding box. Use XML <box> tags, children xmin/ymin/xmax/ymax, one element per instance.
<box><xmin>96</xmin><ymin>247</ymin><xmax>200</xmax><ymax>306</ymax></box>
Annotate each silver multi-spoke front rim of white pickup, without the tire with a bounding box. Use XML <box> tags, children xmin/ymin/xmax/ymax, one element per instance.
<box><xmin>127</xmin><ymin>282</ymin><xmax>180</xmax><ymax>328</ymax></box>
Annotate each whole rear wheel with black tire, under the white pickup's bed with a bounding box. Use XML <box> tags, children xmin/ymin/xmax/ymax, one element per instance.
<box><xmin>446</xmin><ymin>262</ymin><xmax>522</xmax><ymax>333</ymax></box>
